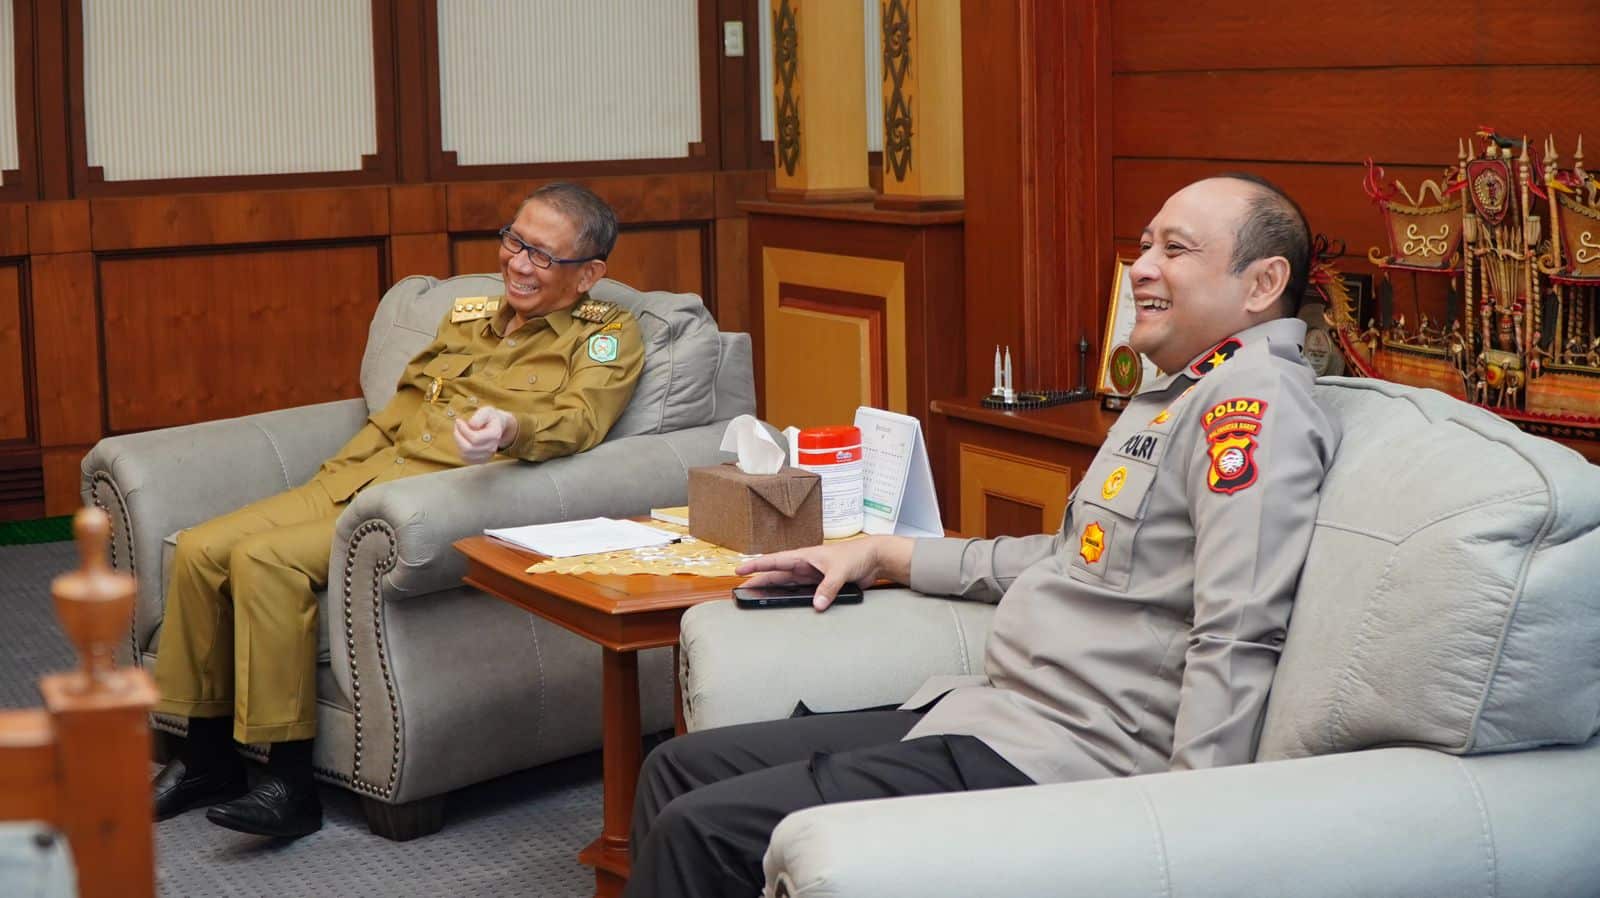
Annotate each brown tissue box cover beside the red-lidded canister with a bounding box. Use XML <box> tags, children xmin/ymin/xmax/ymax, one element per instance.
<box><xmin>690</xmin><ymin>464</ymin><xmax>822</xmax><ymax>555</ymax></box>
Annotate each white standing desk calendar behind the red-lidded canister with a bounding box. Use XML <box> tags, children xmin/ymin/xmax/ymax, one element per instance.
<box><xmin>856</xmin><ymin>405</ymin><xmax>944</xmax><ymax>536</ymax></box>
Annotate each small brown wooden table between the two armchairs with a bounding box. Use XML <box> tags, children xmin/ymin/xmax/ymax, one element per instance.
<box><xmin>456</xmin><ymin>536</ymin><xmax>744</xmax><ymax>896</ymax></box>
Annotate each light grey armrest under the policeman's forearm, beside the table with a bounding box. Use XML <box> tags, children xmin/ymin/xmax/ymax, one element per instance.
<box><xmin>678</xmin><ymin>589</ymin><xmax>994</xmax><ymax>730</ymax></box>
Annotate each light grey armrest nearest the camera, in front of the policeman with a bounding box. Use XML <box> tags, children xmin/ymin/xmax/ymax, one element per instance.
<box><xmin>765</xmin><ymin>740</ymin><xmax>1600</xmax><ymax>898</ymax></box>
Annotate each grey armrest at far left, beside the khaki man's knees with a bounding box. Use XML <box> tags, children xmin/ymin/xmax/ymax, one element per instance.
<box><xmin>82</xmin><ymin>399</ymin><xmax>366</xmax><ymax>658</ymax></box>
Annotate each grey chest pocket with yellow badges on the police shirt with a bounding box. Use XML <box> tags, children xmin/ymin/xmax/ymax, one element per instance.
<box><xmin>1066</xmin><ymin>453</ymin><xmax>1158</xmax><ymax>591</ymax></box>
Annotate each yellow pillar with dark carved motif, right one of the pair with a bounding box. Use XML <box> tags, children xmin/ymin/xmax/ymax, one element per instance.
<box><xmin>877</xmin><ymin>0</ymin><xmax>962</xmax><ymax>210</ymax></box>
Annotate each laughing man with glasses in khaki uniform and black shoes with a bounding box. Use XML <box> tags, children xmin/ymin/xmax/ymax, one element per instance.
<box><xmin>154</xmin><ymin>184</ymin><xmax>645</xmax><ymax>839</ymax></box>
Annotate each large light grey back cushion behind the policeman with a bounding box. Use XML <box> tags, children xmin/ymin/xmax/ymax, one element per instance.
<box><xmin>1258</xmin><ymin>378</ymin><xmax>1600</xmax><ymax>760</ymax></box>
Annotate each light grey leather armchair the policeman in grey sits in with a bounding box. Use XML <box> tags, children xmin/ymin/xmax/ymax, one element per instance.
<box><xmin>682</xmin><ymin>378</ymin><xmax>1600</xmax><ymax>898</ymax></box>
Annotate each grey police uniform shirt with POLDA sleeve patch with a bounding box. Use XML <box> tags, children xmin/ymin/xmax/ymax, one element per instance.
<box><xmin>901</xmin><ymin>319</ymin><xmax>1339</xmax><ymax>783</ymax></box>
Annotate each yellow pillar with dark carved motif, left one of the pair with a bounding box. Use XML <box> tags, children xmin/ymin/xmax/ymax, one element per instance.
<box><xmin>768</xmin><ymin>0</ymin><xmax>872</xmax><ymax>203</ymax></box>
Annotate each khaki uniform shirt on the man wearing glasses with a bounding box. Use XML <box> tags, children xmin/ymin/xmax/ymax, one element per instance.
<box><xmin>315</xmin><ymin>295</ymin><xmax>645</xmax><ymax>503</ymax></box>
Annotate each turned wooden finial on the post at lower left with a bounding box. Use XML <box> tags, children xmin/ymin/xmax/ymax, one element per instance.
<box><xmin>50</xmin><ymin>507</ymin><xmax>134</xmax><ymax>692</ymax></box>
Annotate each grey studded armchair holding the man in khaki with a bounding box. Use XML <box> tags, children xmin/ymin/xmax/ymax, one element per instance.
<box><xmin>83</xmin><ymin>275</ymin><xmax>755</xmax><ymax>839</ymax></box>
